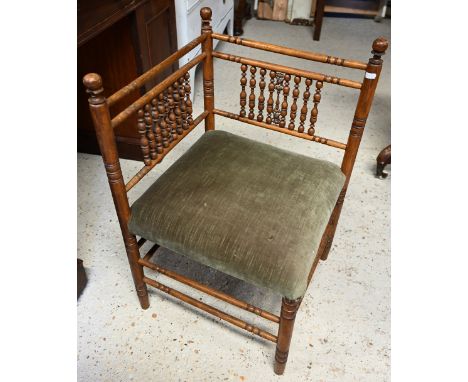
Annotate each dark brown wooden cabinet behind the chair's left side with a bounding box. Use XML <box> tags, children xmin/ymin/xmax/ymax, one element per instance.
<box><xmin>77</xmin><ymin>0</ymin><xmax>178</xmax><ymax>160</ymax></box>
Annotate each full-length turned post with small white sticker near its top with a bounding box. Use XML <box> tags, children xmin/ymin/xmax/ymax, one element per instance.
<box><xmin>318</xmin><ymin>37</ymin><xmax>388</xmax><ymax>260</ymax></box>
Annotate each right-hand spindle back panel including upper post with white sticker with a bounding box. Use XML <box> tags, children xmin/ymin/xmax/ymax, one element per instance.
<box><xmin>211</xmin><ymin>33</ymin><xmax>388</xmax><ymax>188</ymax></box>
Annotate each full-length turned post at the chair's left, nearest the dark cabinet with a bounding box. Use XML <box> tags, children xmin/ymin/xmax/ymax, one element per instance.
<box><xmin>83</xmin><ymin>73</ymin><xmax>149</xmax><ymax>309</ymax></box>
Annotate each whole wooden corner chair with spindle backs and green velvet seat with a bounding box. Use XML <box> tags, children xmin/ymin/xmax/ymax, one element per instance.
<box><xmin>83</xmin><ymin>8</ymin><xmax>388</xmax><ymax>374</ymax></box>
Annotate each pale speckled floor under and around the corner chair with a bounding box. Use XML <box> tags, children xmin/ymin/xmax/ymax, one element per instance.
<box><xmin>78</xmin><ymin>18</ymin><xmax>391</xmax><ymax>382</ymax></box>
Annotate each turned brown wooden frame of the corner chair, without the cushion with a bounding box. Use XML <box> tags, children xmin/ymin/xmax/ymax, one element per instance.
<box><xmin>83</xmin><ymin>8</ymin><xmax>388</xmax><ymax>374</ymax></box>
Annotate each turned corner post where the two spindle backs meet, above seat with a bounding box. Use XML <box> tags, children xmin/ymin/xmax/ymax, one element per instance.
<box><xmin>200</xmin><ymin>7</ymin><xmax>215</xmax><ymax>131</ymax></box>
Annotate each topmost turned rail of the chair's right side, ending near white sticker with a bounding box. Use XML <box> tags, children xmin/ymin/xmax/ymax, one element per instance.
<box><xmin>211</xmin><ymin>33</ymin><xmax>367</xmax><ymax>70</ymax></box>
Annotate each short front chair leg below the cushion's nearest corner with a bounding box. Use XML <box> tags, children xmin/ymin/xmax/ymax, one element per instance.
<box><xmin>274</xmin><ymin>297</ymin><xmax>301</xmax><ymax>375</ymax></box>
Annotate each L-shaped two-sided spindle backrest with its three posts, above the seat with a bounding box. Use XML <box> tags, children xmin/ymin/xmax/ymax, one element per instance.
<box><xmin>83</xmin><ymin>8</ymin><xmax>388</xmax><ymax>199</ymax></box>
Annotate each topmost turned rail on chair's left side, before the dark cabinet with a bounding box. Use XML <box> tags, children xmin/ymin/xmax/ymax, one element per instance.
<box><xmin>107</xmin><ymin>34</ymin><xmax>207</xmax><ymax>106</ymax></box>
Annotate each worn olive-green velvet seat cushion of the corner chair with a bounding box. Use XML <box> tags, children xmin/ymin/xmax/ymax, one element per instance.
<box><xmin>129</xmin><ymin>130</ymin><xmax>345</xmax><ymax>299</ymax></box>
